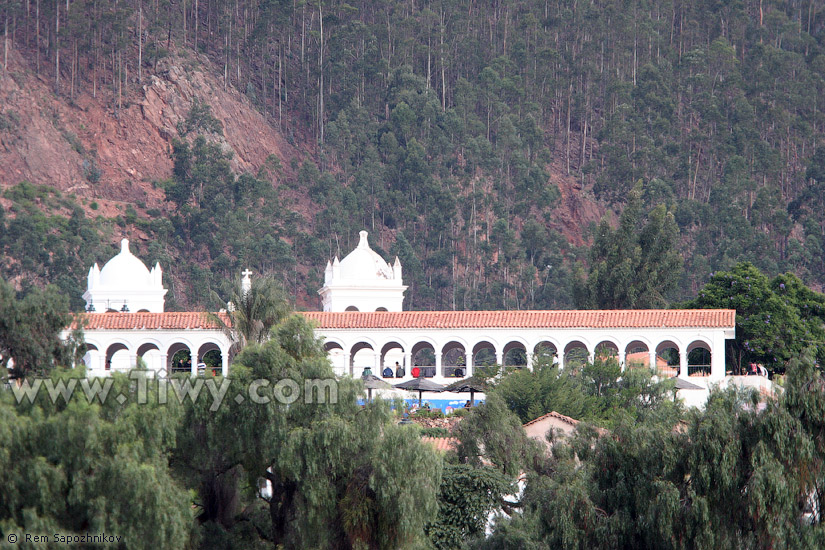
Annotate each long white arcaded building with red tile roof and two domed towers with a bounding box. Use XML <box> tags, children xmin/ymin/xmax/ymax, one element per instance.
<box><xmin>66</xmin><ymin>231</ymin><xmax>735</xmax><ymax>406</ymax></box>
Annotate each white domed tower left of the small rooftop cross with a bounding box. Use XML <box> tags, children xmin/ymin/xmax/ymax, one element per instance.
<box><xmin>83</xmin><ymin>239</ymin><xmax>167</xmax><ymax>313</ymax></box>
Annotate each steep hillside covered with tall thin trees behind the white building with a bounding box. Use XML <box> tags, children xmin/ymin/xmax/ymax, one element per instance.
<box><xmin>0</xmin><ymin>0</ymin><xmax>825</xmax><ymax>309</ymax></box>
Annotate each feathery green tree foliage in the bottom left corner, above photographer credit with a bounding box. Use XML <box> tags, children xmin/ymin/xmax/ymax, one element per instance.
<box><xmin>0</xmin><ymin>370</ymin><xmax>192</xmax><ymax>549</ymax></box>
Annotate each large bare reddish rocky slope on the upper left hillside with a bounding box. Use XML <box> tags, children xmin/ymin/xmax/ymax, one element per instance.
<box><xmin>0</xmin><ymin>47</ymin><xmax>296</xmax><ymax>212</ymax></box>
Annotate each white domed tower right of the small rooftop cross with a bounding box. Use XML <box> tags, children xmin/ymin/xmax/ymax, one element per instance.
<box><xmin>318</xmin><ymin>231</ymin><xmax>407</xmax><ymax>311</ymax></box>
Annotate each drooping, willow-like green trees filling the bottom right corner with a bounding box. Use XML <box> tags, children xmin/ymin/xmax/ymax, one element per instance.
<box><xmin>476</xmin><ymin>357</ymin><xmax>825</xmax><ymax>549</ymax></box>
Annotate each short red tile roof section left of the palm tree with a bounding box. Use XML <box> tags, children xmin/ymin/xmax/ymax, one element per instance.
<box><xmin>70</xmin><ymin>311</ymin><xmax>229</xmax><ymax>330</ymax></box>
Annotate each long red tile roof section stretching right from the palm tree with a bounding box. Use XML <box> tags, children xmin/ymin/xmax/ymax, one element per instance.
<box><xmin>303</xmin><ymin>309</ymin><xmax>736</xmax><ymax>329</ymax></box>
